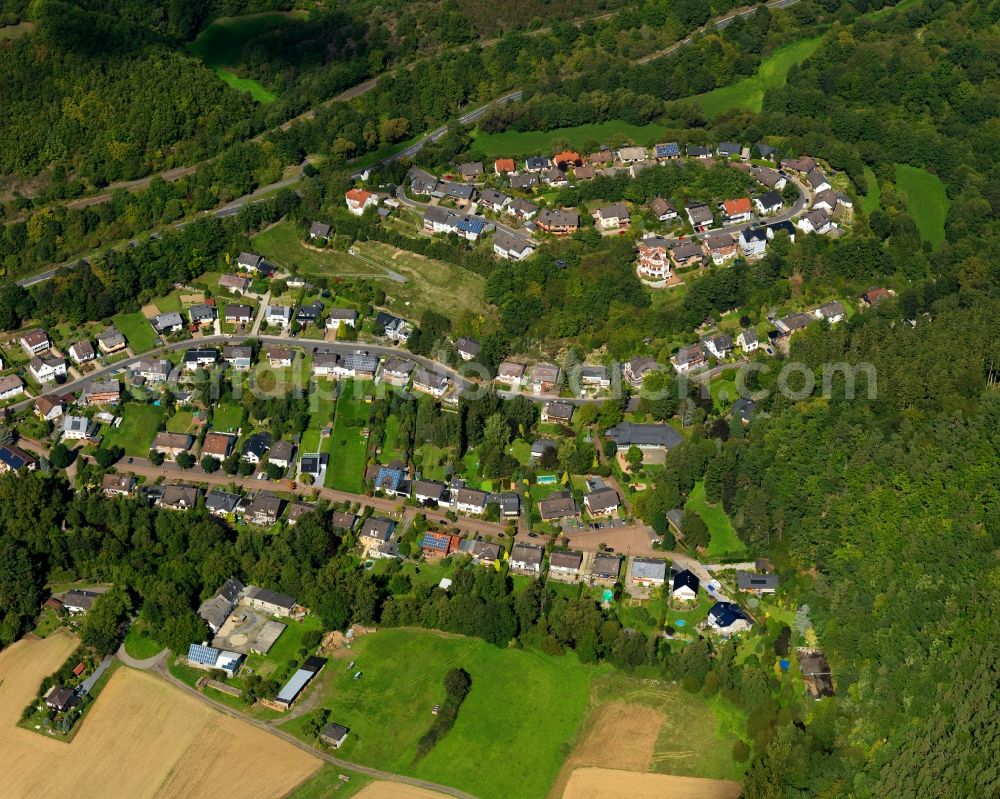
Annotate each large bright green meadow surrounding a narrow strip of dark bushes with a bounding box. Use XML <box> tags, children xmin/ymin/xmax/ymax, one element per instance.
<box><xmin>282</xmin><ymin>630</ymin><xmax>601</xmax><ymax>799</ymax></box>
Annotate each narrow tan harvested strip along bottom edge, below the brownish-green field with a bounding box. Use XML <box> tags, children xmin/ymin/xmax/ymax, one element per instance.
<box><xmin>564</xmin><ymin>768</ymin><xmax>740</xmax><ymax>799</ymax></box>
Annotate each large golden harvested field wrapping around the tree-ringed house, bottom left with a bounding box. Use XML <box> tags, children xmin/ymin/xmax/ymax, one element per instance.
<box><xmin>0</xmin><ymin>633</ymin><xmax>320</xmax><ymax>799</ymax></box>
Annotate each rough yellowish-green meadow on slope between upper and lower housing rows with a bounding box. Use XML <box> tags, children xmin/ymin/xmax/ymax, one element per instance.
<box><xmin>253</xmin><ymin>221</ymin><xmax>486</xmax><ymax>319</ymax></box>
